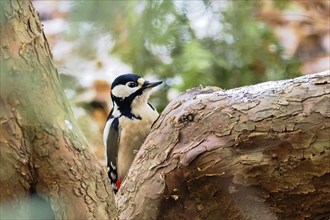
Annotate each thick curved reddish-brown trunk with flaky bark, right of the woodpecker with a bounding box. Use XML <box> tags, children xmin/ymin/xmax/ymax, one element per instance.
<box><xmin>117</xmin><ymin>71</ymin><xmax>330</xmax><ymax>219</ymax></box>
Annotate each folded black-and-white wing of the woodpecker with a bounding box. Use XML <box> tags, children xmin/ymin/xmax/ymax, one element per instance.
<box><xmin>103</xmin><ymin>117</ymin><xmax>120</xmax><ymax>192</ymax></box>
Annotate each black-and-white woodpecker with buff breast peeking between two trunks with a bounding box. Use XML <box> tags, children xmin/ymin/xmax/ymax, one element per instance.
<box><xmin>103</xmin><ymin>74</ymin><xmax>162</xmax><ymax>193</ymax></box>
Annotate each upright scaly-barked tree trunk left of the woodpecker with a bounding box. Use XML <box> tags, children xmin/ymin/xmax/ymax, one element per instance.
<box><xmin>0</xmin><ymin>0</ymin><xmax>116</xmax><ymax>219</ymax></box>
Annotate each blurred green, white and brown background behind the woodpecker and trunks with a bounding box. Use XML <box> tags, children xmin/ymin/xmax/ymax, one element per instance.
<box><xmin>33</xmin><ymin>0</ymin><xmax>330</xmax><ymax>161</ymax></box>
